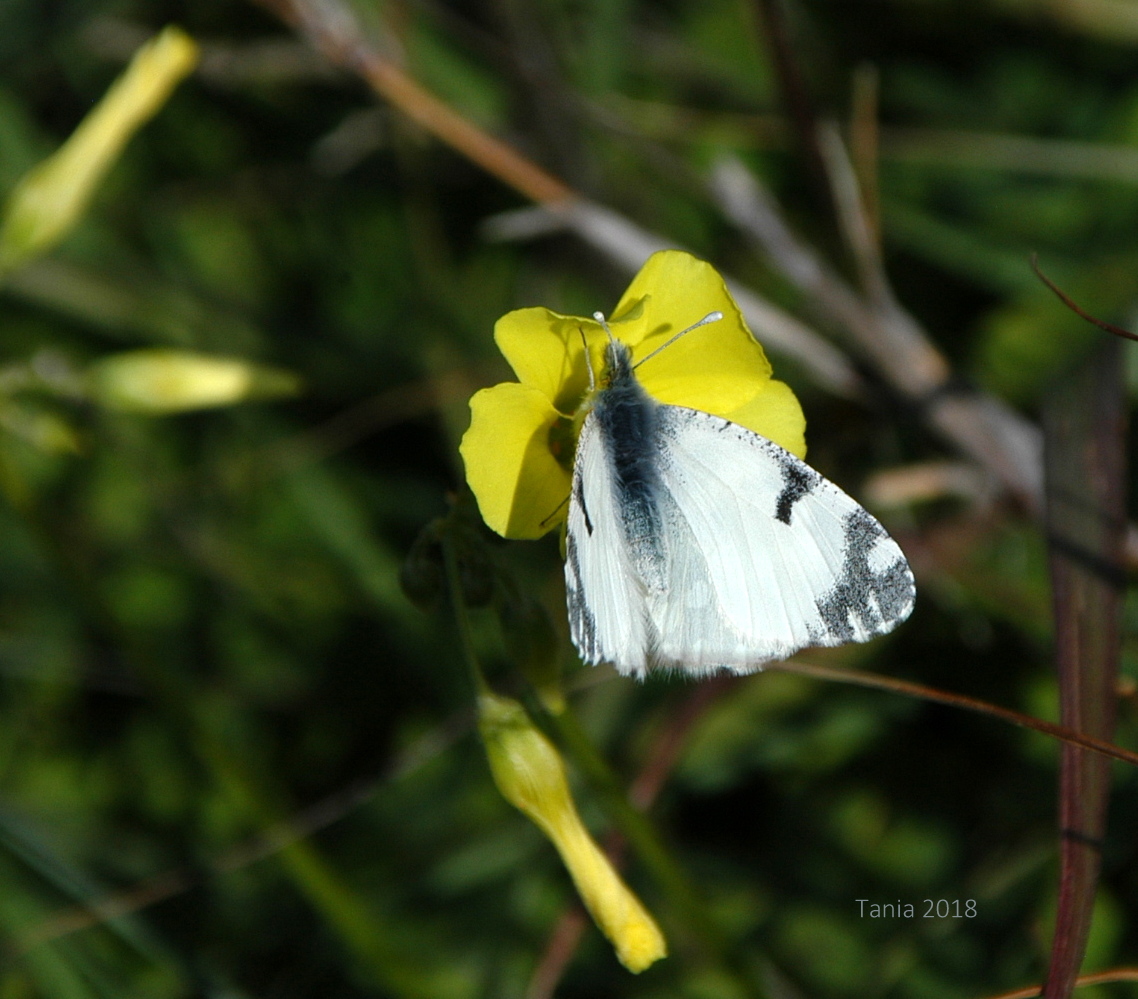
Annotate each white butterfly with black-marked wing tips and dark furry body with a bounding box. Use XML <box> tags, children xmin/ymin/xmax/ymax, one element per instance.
<box><xmin>566</xmin><ymin>313</ymin><xmax>916</xmax><ymax>677</ymax></box>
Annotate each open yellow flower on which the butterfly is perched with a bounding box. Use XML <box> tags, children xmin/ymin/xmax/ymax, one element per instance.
<box><xmin>460</xmin><ymin>250</ymin><xmax>806</xmax><ymax>538</ymax></box>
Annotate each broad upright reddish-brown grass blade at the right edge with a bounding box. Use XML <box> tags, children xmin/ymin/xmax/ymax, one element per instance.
<box><xmin>1044</xmin><ymin>341</ymin><xmax>1125</xmax><ymax>999</ymax></box>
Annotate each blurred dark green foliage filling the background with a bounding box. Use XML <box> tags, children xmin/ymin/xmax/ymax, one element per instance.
<box><xmin>0</xmin><ymin>0</ymin><xmax>1138</xmax><ymax>999</ymax></box>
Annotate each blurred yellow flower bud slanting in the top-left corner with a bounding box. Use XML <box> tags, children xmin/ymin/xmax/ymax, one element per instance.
<box><xmin>0</xmin><ymin>27</ymin><xmax>198</xmax><ymax>271</ymax></box>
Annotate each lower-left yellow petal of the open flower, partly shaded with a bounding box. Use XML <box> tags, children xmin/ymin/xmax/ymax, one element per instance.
<box><xmin>459</xmin><ymin>382</ymin><xmax>570</xmax><ymax>538</ymax></box>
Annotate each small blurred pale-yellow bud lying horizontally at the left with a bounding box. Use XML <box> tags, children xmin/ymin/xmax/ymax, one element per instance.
<box><xmin>88</xmin><ymin>349</ymin><xmax>299</xmax><ymax>415</ymax></box>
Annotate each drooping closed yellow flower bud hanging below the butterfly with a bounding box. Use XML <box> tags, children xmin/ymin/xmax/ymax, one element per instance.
<box><xmin>478</xmin><ymin>694</ymin><xmax>668</xmax><ymax>973</ymax></box>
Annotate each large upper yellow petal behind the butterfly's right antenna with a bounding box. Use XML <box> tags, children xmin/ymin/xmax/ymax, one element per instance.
<box><xmin>612</xmin><ymin>250</ymin><xmax>770</xmax><ymax>415</ymax></box>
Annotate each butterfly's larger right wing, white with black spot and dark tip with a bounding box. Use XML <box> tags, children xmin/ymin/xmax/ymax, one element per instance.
<box><xmin>650</xmin><ymin>406</ymin><xmax>915</xmax><ymax>672</ymax></box>
